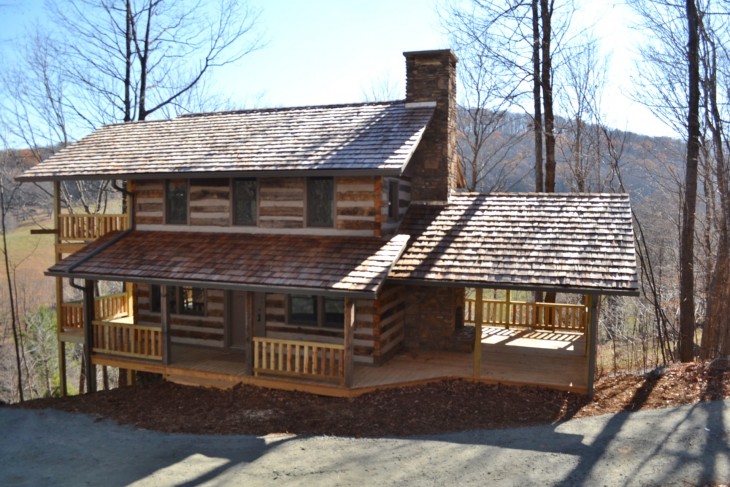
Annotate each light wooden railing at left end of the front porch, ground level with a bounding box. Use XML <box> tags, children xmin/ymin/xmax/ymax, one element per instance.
<box><xmin>92</xmin><ymin>321</ymin><xmax>162</xmax><ymax>360</ymax></box>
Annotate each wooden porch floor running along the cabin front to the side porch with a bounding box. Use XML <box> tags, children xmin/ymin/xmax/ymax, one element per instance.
<box><xmin>94</xmin><ymin>327</ymin><xmax>587</xmax><ymax>396</ymax></box>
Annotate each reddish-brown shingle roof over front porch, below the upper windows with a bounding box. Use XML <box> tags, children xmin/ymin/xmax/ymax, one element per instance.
<box><xmin>48</xmin><ymin>231</ymin><xmax>408</xmax><ymax>298</ymax></box>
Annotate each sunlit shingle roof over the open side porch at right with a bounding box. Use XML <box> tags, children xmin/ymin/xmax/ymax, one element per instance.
<box><xmin>388</xmin><ymin>193</ymin><xmax>638</xmax><ymax>294</ymax></box>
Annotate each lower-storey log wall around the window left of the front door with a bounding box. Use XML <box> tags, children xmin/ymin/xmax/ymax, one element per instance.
<box><xmin>135</xmin><ymin>284</ymin><xmax>225</xmax><ymax>348</ymax></box>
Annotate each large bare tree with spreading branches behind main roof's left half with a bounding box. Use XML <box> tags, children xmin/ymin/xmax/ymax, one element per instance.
<box><xmin>49</xmin><ymin>0</ymin><xmax>261</xmax><ymax>128</ymax></box>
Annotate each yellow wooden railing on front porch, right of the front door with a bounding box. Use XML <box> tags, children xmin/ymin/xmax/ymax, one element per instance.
<box><xmin>253</xmin><ymin>337</ymin><xmax>345</xmax><ymax>383</ymax></box>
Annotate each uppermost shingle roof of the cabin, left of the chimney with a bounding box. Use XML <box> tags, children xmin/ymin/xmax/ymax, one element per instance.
<box><xmin>21</xmin><ymin>101</ymin><xmax>434</xmax><ymax>180</ymax></box>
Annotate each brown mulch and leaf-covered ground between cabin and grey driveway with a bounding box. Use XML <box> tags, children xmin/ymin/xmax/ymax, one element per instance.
<box><xmin>12</xmin><ymin>361</ymin><xmax>730</xmax><ymax>437</ymax></box>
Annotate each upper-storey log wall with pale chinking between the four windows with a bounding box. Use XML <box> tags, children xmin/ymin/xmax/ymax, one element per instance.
<box><xmin>134</xmin><ymin>176</ymin><xmax>382</xmax><ymax>236</ymax></box>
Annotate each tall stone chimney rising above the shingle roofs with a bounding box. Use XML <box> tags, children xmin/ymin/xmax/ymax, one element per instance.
<box><xmin>403</xmin><ymin>49</ymin><xmax>459</xmax><ymax>203</ymax></box>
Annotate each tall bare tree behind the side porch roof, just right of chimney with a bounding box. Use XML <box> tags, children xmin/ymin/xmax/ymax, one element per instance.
<box><xmin>442</xmin><ymin>0</ymin><xmax>574</xmax><ymax>191</ymax></box>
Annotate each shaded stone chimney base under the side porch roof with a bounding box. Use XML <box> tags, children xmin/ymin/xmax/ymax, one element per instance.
<box><xmin>405</xmin><ymin>286</ymin><xmax>464</xmax><ymax>350</ymax></box>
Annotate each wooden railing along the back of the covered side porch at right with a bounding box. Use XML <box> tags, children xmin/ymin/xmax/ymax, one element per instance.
<box><xmin>464</xmin><ymin>298</ymin><xmax>587</xmax><ymax>333</ymax></box>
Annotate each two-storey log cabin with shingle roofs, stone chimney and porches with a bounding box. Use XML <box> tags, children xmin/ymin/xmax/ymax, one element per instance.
<box><xmin>15</xmin><ymin>50</ymin><xmax>638</xmax><ymax>396</ymax></box>
